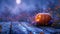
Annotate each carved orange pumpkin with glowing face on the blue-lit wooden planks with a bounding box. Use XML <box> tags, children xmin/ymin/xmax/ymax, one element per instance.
<box><xmin>35</xmin><ymin>13</ymin><xmax>51</xmax><ymax>25</ymax></box>
